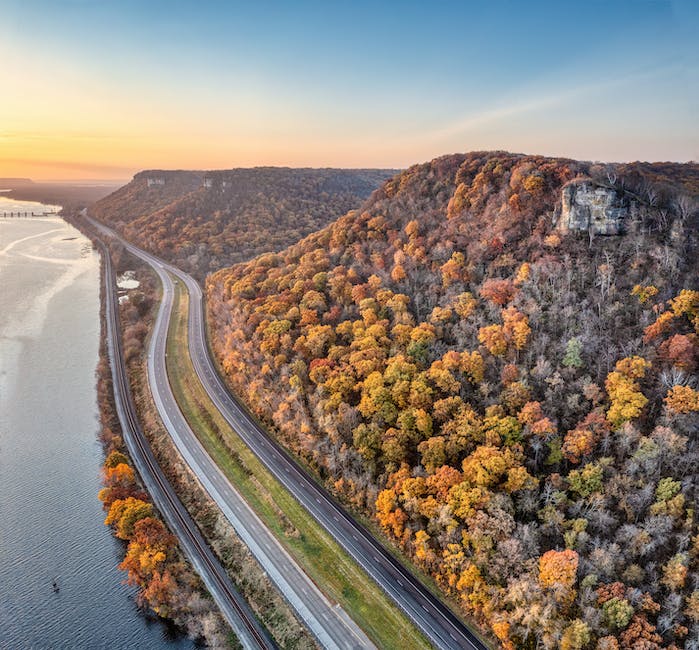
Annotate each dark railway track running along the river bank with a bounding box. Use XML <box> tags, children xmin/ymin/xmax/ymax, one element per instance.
<box><xmin>98</xmin><ymin>240</ymin><xmax>276</xmax><ymax>650</ymax></box>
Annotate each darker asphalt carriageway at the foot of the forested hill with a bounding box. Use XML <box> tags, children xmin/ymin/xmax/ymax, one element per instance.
<box><xmin>90</xmin><ymin>219</ymin><xmax>488</xmax><ymax>650</ymax></box>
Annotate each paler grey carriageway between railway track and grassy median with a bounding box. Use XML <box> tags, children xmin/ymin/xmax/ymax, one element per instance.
<box><xmin>90</xmin><ymin>219</ymin><xmax>374</xmax><ymax>650</ymax></box>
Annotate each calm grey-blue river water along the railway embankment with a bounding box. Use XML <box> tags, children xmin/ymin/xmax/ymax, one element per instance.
<box><xmin>0</xmin><ymin>204</ymin><xmax>193</xmax><ymax>650</ymax></box>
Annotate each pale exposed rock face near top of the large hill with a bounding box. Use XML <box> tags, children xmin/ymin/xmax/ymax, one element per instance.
<box><xmin>558</xmin><ymin>180</ymin><xmax>630</xmax><ymax>235</ymax></box>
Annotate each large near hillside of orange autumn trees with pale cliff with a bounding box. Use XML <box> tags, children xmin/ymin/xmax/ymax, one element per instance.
<box><xmin>207</xmin><ymin>153</ymin><xmax>699</xmax><ymax>650</ymax></box>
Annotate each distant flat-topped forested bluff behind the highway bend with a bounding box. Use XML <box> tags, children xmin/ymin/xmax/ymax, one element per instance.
<box><xmin>92</xmin><ymin>167</ymin><xmax>395</xmax><ymax>279</ymax></box>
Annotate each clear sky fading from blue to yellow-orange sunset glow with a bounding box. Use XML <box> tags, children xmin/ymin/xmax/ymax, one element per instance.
<box><xmin>0</xmin><ymin>0</ymin><xmax>699</xmax><ymax>180</ymax></box>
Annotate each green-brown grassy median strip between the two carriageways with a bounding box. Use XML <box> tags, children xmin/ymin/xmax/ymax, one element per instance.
<box><xmin>167</xmin><ymin>282</ymin><xmax>430</xmax><ymax>650</ymax></box>
